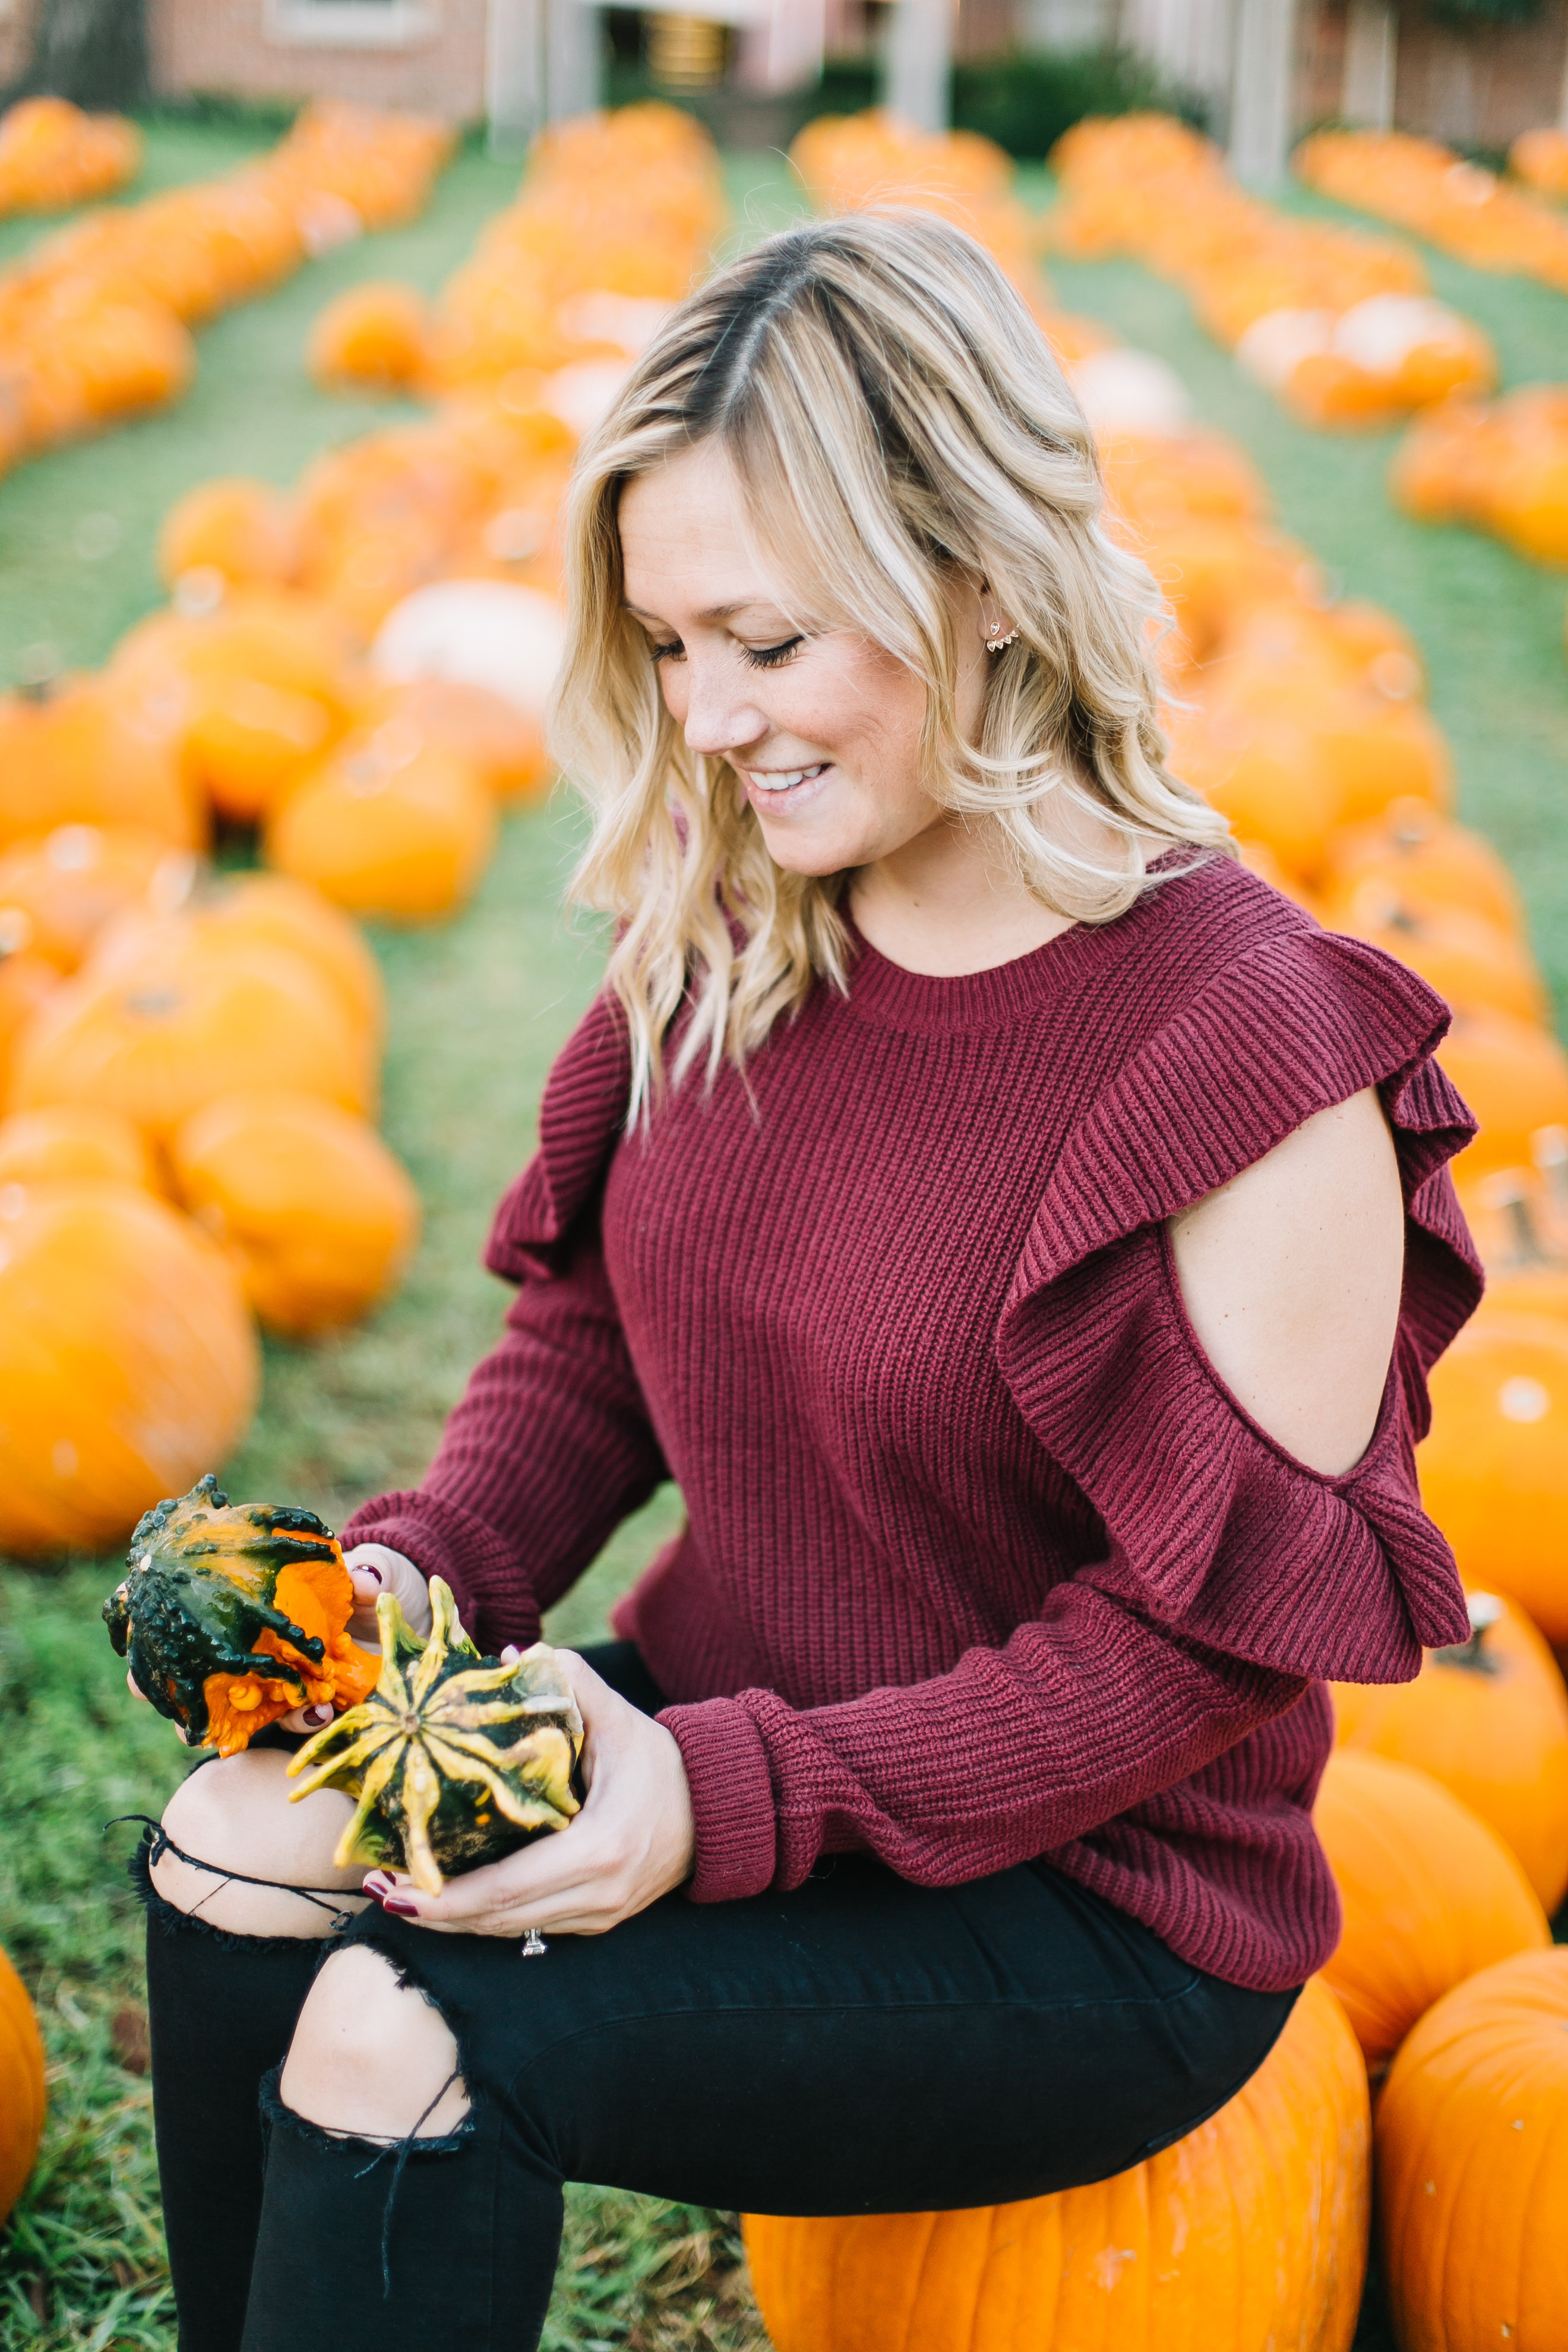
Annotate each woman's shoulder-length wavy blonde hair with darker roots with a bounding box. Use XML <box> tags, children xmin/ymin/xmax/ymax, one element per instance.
<box><xmin>552</xmin><ymin>211</ymin><xmax>1227</xmax><ymax>1120</ymax></box>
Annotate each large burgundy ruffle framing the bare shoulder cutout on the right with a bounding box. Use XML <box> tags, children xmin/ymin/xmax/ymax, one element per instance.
<box><xmin>997</xmin><ymin>931</ymin><xmax>1481</xmax><ymax>1681</ymax></box>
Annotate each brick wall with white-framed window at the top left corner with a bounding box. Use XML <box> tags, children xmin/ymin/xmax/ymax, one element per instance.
<box><xmin>148</xmin><ymin>0</ymin><xmax>486</xmax><ymax>122</ymax></box>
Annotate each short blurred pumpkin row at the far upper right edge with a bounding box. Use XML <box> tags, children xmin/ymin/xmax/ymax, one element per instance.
<box><xmin>1295</xmin><ymin>132</ymin><xmax>1568</xmax><ymax>294</ymax></box>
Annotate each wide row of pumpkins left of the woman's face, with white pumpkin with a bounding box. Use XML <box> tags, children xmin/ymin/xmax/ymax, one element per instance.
<box><xmin>0</xmin><ymin>108</ymin><xmax>738</xmax><ymax>1553</ymax></box>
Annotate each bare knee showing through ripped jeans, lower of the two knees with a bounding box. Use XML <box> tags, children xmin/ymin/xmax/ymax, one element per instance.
<box><xmin>280</xmin><ymin>1945</ymin><xmax>468</xmax><ymax>2141</ymax></box>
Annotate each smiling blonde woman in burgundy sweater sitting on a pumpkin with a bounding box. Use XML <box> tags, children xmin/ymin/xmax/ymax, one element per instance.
<box><xmin>135</xmin><ymin>216</ymin><xmax>1479</xmax><ymax>2352</ymax></box>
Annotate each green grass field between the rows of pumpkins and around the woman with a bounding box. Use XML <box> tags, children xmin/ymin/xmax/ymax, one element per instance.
<box><xmin>0</xmin><ymin>125</ymin><xmax>1568</xmax><ymax>2352</ymax></box>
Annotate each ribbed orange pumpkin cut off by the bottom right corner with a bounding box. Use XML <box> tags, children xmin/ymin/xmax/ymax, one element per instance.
<box><xmin>1377</xmin><ymin>1950</ymin><xmax>1568</xmax><ymax>2352</ymax></box>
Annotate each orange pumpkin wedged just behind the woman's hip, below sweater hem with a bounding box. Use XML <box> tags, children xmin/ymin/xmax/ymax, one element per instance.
<box><xmin>1312</xmin><ymin>1747</ymin><xmax>1551</xmax><ymax>2072</ymax></box>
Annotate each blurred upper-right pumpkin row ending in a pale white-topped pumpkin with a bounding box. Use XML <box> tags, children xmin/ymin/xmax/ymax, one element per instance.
<box><xmin>1046</xmin><ymin>113</ymin><xmax>1497</xmax><ymax>426</ymax></box>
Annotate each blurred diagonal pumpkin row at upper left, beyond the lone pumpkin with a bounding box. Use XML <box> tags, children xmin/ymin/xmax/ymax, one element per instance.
<box><xmin>0</xmin><ymin>101</ymin><xmax>451</xmax><ymax>470</ymax></box>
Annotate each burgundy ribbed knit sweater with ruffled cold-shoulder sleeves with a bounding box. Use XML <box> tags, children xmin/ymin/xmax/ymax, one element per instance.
<box><xmin>348</xmin><ymin>858</ymin><xmax>1481</xmax><ymax>1987</ymax></box>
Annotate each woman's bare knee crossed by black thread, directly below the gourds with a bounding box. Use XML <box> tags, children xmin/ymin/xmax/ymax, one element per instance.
<box><xmin>153</xmin><ymin>1747</ymin><xmax>364</xmax><ymax>1938</ymax></box>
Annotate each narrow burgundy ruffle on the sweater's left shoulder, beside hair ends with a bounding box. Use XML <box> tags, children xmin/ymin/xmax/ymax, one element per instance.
<box><xmin>484</xmin><ymin>992</ymin><xmax>633</xmax><ymax>1282</ymax></box>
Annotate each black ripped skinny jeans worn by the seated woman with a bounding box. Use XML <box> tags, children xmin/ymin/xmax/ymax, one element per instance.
<box><xmin>148</xmin><ymin>1644</ymin><xmax>1295</xmax><ymax>2352</ymax></box>
